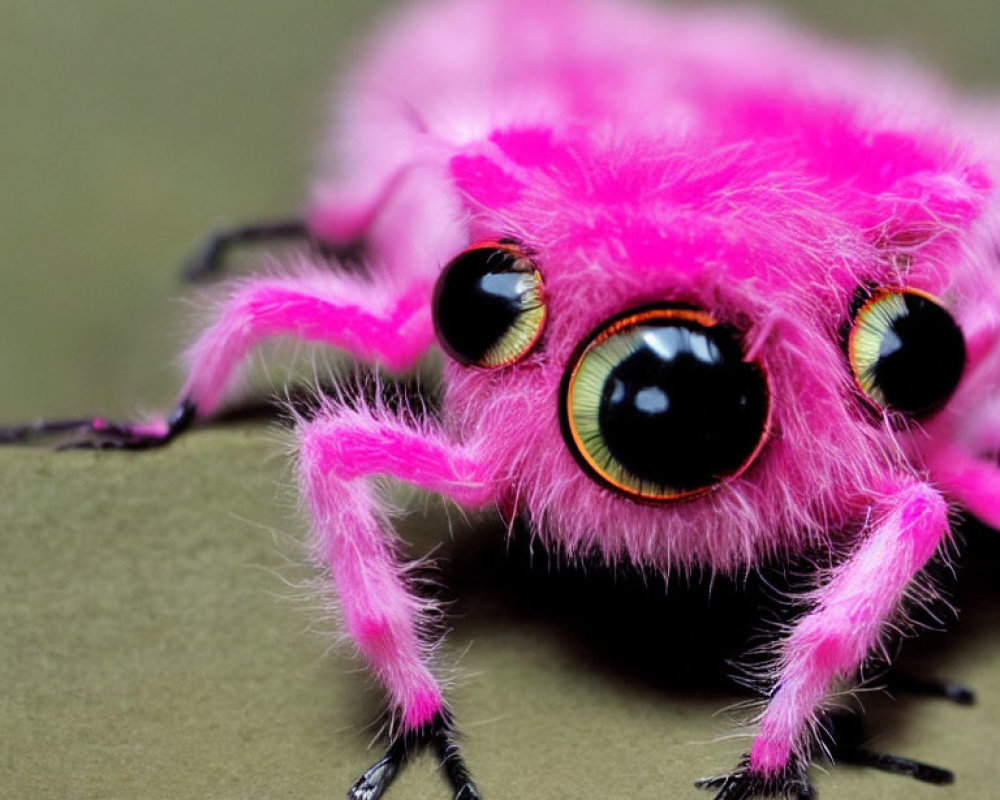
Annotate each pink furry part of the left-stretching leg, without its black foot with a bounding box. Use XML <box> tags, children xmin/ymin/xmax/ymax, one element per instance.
<box><xmin>181</xmin><ymin>275</ymin><xmax>434</xmax><ymax>416</ymax></box>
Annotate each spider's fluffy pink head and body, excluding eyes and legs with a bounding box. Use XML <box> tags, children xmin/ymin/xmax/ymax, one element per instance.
<box><xmin>312</xmin><ymin>0</ymin><xmax>992</xmax><ymax>570</ymax></box>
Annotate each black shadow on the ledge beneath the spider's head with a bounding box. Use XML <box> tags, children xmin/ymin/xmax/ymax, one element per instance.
<box><xmin>436</xmin><ymin>522</ymin><xmax>1000</xmax><ymax>708</ymax></box>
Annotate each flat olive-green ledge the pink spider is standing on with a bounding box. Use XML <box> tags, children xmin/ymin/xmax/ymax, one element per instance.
<box><xmin>0</xmin><ymin>432</ymin><xmax>1000</xmax><ymax>800</ymax></box>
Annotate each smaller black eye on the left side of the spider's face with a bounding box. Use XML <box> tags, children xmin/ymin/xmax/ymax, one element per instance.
<box><xmin>434</xmin><ymin>242</ymin><xmax>545</xmax><ymax>367</ymax></box>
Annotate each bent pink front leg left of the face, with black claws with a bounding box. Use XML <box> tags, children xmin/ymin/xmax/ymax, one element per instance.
<box><xmin>299</xmin><ymin>409</ymin><xmax>494</xmax><ymax>800</ymax></box>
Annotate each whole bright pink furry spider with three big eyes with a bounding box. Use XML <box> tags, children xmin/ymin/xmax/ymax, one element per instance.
<box><xmin>7</xmin><ymin>0</ymin><xmax>1000</xmax><ymax>800</ymax></box>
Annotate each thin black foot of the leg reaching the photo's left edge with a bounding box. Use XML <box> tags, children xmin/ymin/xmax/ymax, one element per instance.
<box><xmin>0</xmin><ymin>400</ymin><xmax>197</xmax><ymax>450</ymax></box>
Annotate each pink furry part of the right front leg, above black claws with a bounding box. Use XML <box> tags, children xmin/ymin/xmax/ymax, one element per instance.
<box><xmin>749</xmin><ymin>481</ymin><xmax>948</xmax><ymax>779</ymax></box>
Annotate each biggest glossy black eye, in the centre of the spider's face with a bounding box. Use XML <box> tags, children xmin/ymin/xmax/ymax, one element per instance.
<box><xmin>561</xmin><ymin>305</ymin><xmax>769</xmax><ymax>501</ymax></box>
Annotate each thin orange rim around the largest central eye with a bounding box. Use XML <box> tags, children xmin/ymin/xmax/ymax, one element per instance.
<box><xmin>559</xmin><ymin>303</ymin><xmax>774</xmax><ymax>505</ymax></box>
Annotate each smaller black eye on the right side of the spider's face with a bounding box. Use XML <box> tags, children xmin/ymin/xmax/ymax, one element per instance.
<box><xmin>847</xmin><ymin>289</ymin><xmax>965</xmax><ymax>417</ymax></box>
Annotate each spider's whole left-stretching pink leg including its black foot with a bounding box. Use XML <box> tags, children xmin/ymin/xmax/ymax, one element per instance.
<box><xmin>0</xmin><ymin>274</ymin><xmax>434</xmax><ymax>450</ymax></box>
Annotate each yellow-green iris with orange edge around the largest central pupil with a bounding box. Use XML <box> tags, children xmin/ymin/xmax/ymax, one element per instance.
<box><xmin>566</xmin><ymin>308</ymin><xmax>736</xmax><ymax>503</ymax></box>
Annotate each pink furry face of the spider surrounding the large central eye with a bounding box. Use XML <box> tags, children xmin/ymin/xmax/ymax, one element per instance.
<box><xmin>445</xmin><ymin>139</ymin><xmax>940</xmax><ymax>570</ymax></box>
